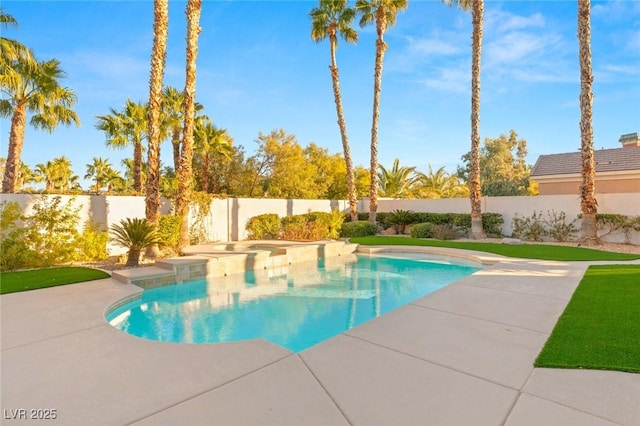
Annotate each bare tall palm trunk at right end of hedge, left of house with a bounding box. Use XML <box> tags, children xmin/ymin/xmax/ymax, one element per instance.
<box><xmin>469</xmin><ymin>0</ymin><xmax>486</xmax><ymax>239</ymax></box>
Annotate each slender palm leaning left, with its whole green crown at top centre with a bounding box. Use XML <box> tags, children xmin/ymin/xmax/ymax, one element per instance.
<box><xmin>310</xmin><ymin>0</ymin><xmax>358</xmax><ymax>221</ymax></box>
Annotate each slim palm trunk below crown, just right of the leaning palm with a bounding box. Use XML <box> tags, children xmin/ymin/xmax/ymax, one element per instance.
<box><xmin>369</xmin><ymin>7</ymin><xmax>387</xmax><ymax>223</ymax></box>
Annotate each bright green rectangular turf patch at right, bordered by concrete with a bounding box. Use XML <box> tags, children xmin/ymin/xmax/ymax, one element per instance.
<box><xmin>534</xmin><ymin>265</ymin><xmax>640</xmax><ymax>373</ymax></box>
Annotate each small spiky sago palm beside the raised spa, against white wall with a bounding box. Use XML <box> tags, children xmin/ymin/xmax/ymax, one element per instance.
<box><xmin>111</xmin><ymin>218</ymin><xmax>162</xmax><ymax>266</ymax></box>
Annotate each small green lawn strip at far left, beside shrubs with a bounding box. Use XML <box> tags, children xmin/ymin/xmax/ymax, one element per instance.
<box><xmin>0</xmin><ymin>267</ymin><xmax>110</xmax><ymax>294</ymax></box>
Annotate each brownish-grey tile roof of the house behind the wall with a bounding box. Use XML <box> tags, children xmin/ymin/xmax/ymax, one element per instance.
<box><xmin>531</xmin><ymin>147</ymin><xmax>640</xmax><ymax>177</ymax></box>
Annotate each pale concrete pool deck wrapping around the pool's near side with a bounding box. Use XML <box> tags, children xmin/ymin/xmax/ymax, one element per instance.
<box><xmin>0</xmin><ymin>250</ymin><xmax>640</xmax><ymax>426</ymax></box>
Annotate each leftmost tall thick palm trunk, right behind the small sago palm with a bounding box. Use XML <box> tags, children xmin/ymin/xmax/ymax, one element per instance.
<box><xmin>145</xmin><ymin>0</ymin><xmax>169</xmax><ymax>257</ymax></box>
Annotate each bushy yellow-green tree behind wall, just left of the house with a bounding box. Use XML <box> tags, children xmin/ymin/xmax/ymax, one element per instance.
<box><xmin>458</xmin><ymin>130</ymin><xmax>531</xmax><ymax>197</ymax></box>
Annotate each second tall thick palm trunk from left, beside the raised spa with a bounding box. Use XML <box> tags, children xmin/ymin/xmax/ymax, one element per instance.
<box><xmin>176</xmin><ymin>0</ymin><xmax>202</xmax><ymax>249</ymax></box>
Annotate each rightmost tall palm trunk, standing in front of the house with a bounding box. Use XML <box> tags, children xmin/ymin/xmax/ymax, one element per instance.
<box><xmin>578</xmin><ymin>0</ymin><xmax>602</xmax><ymax>246</ymax></box>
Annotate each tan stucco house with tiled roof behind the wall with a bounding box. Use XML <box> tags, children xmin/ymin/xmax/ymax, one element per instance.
<box><xmin>531</xmin><ymin>133</ymin><xmax>640</xmax><ymax>195</ymax></box>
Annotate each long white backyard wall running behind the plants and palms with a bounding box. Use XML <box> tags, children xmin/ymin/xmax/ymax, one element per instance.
<box><xmin>1</xmin><ymin>193</ymin><xmax>640</xmax><ymax>255</ymax></box>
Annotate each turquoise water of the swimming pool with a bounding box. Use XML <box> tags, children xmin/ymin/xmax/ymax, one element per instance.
<box><xmin>107</xmin><ymin>255</ymin><xmax>479</xmax><ymax>352</ymax></box>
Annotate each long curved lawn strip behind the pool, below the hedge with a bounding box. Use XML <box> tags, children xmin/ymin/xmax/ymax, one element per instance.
<box><xmin>349</xmin><ymin>236</ymin><xmax>640</xmax><ymax>261</ymax></box>
